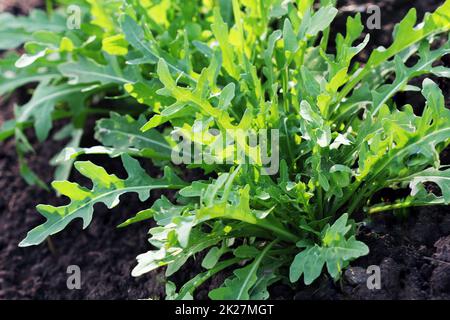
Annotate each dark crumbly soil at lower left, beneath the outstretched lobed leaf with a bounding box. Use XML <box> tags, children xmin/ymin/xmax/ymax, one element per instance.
<box><xmin>0</xmin><ymin>123</ymin><xmax>167</xmax><ymax>299</ymax></box>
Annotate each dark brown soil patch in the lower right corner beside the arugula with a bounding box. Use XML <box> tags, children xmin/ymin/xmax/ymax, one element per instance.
<box><xmin>272</xmin><ymin>207</ymin><xmax>450</xmax><ymax>300</ymax></box>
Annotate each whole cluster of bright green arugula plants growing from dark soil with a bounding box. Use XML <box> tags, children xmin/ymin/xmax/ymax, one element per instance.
<box><xmin>0</xmin><ymin>0</ymin><xmax>450</xmax><ymax>299</ymax></box>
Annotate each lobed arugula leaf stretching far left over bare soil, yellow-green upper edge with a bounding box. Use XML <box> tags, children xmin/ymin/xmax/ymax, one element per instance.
<box><xmin>19</xmin><ymin>155</ymin><xmax>185</xmax><ymax>247</ymax></box>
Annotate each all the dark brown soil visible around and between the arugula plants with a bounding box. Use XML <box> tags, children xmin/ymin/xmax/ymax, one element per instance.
<box><xmin>0</xmin><ymin>0</ymin><xmax>450</xmax><ymax>299</ymax></box>
